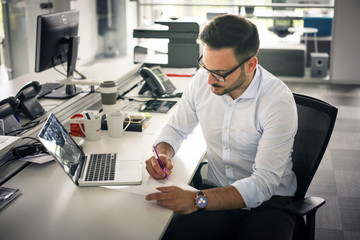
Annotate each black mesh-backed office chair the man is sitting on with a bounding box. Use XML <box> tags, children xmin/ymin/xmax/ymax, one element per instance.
<box><xmin>192</xmin><ymin>93</ymin><xmax>337</xmax><ymax>240</ymax></box>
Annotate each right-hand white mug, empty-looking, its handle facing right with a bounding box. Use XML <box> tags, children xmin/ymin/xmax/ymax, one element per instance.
<box><xmin>106</xmin><ymin>112</ymin><xmax>131</xmax><ymax>137</ymax></box>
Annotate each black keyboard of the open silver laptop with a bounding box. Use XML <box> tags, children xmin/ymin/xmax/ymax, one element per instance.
<box><xmin>85</xmin><ymin>153</ymin><xmax>116</xmax><ymax>181</ymax></box>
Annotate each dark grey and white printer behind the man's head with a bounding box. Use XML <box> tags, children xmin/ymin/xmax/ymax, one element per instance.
<box><xmin>133</xmin><ymin>17</ymin><xmax>202</xmax><ymax>68</ymax></box>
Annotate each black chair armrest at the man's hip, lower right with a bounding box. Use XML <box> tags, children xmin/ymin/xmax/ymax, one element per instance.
<box><xmin>282</xmin><ymin>197</ymin><xmax>325</xmax><ymax>216</ymax></box>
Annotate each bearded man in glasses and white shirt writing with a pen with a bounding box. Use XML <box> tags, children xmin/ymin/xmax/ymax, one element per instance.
<box><xmin>146</xmin><ymin>15</ymin><xmax>297</xmax><ymax>239</ymax></box>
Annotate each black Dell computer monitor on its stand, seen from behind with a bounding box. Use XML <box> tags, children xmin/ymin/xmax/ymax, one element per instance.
<box><xmin>35</xmin><ymin>10</ymin><xmax>80</xmax><ymax>98</ymax></box>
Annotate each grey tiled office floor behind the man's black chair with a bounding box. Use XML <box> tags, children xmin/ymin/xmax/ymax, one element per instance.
<box><xmin>286</xmin><ymin>82</ymin><xmax>360</xmax><ymax>240</ymax></box>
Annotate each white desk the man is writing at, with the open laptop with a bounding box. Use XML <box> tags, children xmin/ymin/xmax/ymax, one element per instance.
<box><xmin>0</xmin><ymin>58</ymin><xmax>206</xmax><ymax>240</ymax></box>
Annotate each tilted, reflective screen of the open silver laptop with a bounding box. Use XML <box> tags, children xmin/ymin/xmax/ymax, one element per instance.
<box><xmin>39</xmin><ymin>113</ymin><xmax>85</xmax><ymax>184</ymax></box>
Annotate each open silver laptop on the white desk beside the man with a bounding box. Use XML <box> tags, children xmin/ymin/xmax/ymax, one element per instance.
<box><xmin>38</xmin><ymin>113</ymin><xmax>142</xmax><ymax>186</ymax></box>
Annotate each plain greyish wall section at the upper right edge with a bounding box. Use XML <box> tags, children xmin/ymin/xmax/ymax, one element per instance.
<box><xmin>330</xmin><ymin>0</ymin><xmax>360</xmax><ymax>84</ymax></box>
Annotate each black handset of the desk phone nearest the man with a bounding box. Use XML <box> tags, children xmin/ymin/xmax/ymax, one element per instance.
<box><xmin>139</xmin><ymin>67</ymin><xmax>166</xmax><ymax>97</ymax></box>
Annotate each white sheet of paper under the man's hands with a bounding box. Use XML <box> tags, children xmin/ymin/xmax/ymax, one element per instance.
<box><xmin>104</xmin><ymin>177</ymin><xmax>196</xmax><ymax>196</ymax></box>
